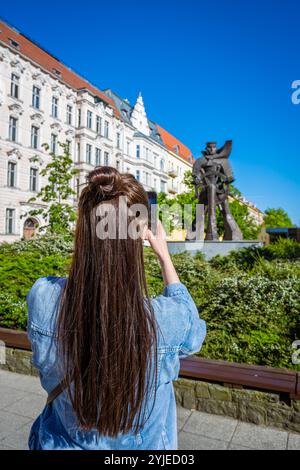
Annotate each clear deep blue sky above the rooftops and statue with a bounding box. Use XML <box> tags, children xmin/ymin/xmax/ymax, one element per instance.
<box><xmin>0</xmin><ymin>0</ymin><xmax>300</xmax><ymax>226</ymax></box>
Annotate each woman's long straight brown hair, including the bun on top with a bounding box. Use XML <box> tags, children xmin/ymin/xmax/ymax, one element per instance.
<box><xmin>58</xmin><ymin>167</ymin><xmax>157</xmax><ymax>437</ymax></box>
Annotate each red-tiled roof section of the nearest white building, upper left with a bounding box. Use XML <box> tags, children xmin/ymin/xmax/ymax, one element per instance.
<box><xmin>0</xmin><ymin>21</ymin><xmax>120</xmax><ymax>117</ymax></box>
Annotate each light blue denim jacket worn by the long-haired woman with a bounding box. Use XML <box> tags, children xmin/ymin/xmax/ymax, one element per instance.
<box><xmin>27</xmin><ymin>276</ymin><xmax>206</xmax><ymax>450</ymax></box>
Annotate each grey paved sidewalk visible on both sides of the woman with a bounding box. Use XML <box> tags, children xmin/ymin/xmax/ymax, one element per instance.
<box><xmin>0</xmin><ymin>370</ymin><xmax>300</xmax><ymax>450</ymax></box>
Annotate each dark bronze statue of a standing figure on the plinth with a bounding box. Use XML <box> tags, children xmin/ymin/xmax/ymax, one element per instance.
<box><xmin>193</xmin><ymin>140</ymin><xmax>243</xmax><ymax>240</ymax></box>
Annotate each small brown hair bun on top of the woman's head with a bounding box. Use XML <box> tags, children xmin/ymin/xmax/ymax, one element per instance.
<box><xmin>87</xmin><ymin>166</ymin><xmax>121</xmax><ymax>196</ymax></box>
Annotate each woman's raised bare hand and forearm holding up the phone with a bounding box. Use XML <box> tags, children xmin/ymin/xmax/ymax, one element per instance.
<box><xmin>144</xmin><ymin>220</ymin><xmax>180</xmax><ymax>285</ymax></box>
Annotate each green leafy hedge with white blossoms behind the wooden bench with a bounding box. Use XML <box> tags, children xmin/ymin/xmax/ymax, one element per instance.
<box><xmin>0</xmin><ymin>237</ymin><xmax>300</xmax><ymax>370</ymax></box>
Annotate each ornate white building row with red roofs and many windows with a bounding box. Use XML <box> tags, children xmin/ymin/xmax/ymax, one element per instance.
<box><xmin>0</xmin><ymin>21</ymin><xmax>193</xmax><ymax>242</ymax></box>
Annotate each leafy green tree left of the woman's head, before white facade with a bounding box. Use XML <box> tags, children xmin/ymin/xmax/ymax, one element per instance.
<box><xmin>28</xmin><ymin>143</ymin><xmax>78</xmax><ymax>233</ymax></box>
